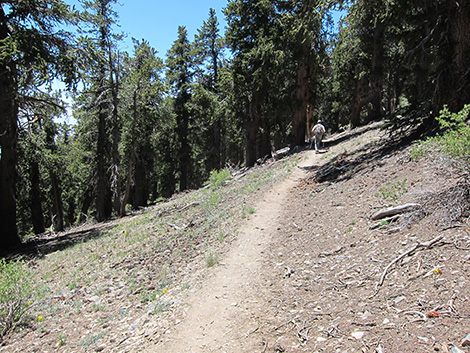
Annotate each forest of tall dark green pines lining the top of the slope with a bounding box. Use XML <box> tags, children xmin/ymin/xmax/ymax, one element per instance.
<box><xmin>0</xmin><ymin>0</ymin><xmax>470</xmax><ymax>252</ymax></box>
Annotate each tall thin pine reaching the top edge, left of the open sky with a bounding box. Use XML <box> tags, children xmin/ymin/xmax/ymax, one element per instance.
<box><xmin>74</xmin><ymin>0</ymin><xmax>121</xmax><ymax>221</ymax></box>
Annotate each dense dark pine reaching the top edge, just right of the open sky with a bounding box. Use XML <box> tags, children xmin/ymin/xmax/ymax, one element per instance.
<box><xmin>225</xmin><ymin>0</ymin><xmax>282</xmax><ymax>167</ymax></box>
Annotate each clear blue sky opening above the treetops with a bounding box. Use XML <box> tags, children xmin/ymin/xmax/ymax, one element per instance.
<box><xmin>65</xmin><ymin>0</ymin><xmax>228</xmax><ymax>58</ymax></box>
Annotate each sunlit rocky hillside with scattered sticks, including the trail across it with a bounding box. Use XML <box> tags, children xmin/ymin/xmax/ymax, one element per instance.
<box><xmin>0</xmin><ymin>124</ymin><xmax>470</xmax><ymax>353</ymax></box>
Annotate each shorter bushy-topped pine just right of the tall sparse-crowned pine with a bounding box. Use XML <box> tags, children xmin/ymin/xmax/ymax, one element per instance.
<box><xmin>120</xmin><ymin>39</ymin><xmax>164</xmax><ymax>216</ymax></box>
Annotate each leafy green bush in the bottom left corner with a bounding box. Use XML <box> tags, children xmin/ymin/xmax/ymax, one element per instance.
<box><xmin>0</xmin><ymin>259</ymin><xmax>37</xmax><ymax>341</ymax></box>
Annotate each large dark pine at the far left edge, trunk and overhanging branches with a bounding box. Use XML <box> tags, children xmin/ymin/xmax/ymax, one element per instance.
<box><xmin>0</xmin><ymin>0</ymin><xmax>73</xmax><ymax>249</ymax></box>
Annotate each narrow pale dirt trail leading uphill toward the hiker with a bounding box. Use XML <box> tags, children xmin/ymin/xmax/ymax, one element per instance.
<box><xmin>153</xmin><ymin>151</ymin><xmax>320</xmax><ymax>352</ymax></box>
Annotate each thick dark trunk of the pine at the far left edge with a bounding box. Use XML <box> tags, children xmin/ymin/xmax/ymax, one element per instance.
<box><xmin>0</xmin><ymin>7</ymin><xmax>21</xmax><ymax>250</ymax></box>
